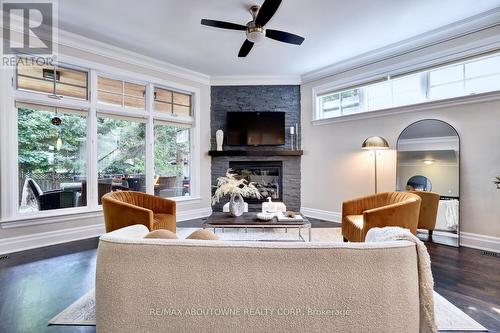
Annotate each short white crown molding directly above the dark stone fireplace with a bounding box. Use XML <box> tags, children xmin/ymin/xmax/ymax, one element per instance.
<box><xmin>210</xmin><ymin>75</ymin><xmax>302</xmax><ymax>86</ymax></box>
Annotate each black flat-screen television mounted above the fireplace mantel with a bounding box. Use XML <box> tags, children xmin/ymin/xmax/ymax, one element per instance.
<box><xmin>227</xmin><ymin>112</ymin><xmax>285</xmax><ymax>146</ymax></box>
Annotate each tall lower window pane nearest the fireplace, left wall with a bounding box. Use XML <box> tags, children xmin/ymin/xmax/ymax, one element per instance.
<box><xmin>154</xmin><ymin>121</ymin><xmax>191</xmax><ymax>198</ymax></box>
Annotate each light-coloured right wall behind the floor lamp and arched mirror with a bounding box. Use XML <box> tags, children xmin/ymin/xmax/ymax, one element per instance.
<box><xmin>301</xmin><ymin>28</ymin><xmax>500</xmax><ymax>246</ymax></box>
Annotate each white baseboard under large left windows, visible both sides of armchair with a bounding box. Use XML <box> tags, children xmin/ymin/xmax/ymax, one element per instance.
<box><xmin>0</xmin><ymin>207</ymin><xmax>212</xmax><ymax>254</ymax></box>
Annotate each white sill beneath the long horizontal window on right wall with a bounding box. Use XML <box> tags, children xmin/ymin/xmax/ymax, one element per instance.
<box><xmin>311</xmin><ymin>91</ymin><xmax>500</xmax><ymax>125</ymax></box>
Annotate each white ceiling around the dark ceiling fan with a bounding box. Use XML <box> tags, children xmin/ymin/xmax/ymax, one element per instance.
<box><xmin>59</xmin><ymin>0</ymin><xmax>500</xmax><ymax>76</ymax></box>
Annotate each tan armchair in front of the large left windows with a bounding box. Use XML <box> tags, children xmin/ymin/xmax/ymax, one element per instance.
<box><xmin>102</xmin><ymin>191</ymin><xmax>176</xmax><ymax>232</ymax></box>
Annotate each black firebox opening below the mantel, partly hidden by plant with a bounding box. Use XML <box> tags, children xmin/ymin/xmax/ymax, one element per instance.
<box><xmin>229</xmin><ymin>161</ymin><xmax>283</xmax><ymax>203</ymax></box>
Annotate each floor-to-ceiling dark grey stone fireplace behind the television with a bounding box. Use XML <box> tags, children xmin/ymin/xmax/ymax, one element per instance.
<box><xmin>209</xmin><ymin>85</ymin><xmax>302</xmax><ymax>212</ymax></box>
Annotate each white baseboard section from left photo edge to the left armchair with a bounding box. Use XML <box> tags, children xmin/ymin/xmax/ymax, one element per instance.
<box><xmin>0</xmin><ymin>223</ymin><xmax>105</xmax><ymax>254</ymax></box>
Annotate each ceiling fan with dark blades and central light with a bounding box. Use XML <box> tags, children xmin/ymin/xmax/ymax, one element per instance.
<box><xmin>201</xmin><ymin>0</ymin><xmax>304</xmax><ymax>57</ymax></box>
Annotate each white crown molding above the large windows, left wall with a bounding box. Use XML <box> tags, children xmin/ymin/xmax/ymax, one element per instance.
<box><xmin>58</xmin><ymin>29</ymin><xmax>210</xmax><ymax>85</ymax></box>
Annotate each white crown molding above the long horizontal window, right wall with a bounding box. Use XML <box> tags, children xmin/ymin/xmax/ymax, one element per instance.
<box><xmin>301</xmin><ymin>7</ymin><xmax>500</xmax><ymax>83</ymax></box>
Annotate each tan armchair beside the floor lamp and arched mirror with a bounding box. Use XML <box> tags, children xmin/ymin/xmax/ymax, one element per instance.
<box><xmin>342</xmin><ymin>192</ymin><xmax>422</xmax><ymax>242</ymax></box>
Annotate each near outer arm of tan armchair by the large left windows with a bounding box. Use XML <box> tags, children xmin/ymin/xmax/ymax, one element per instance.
<box><xmin>102</xmin><ymin>197</ymin><xmax>153</xmax><ymax>232</ymax></box>
